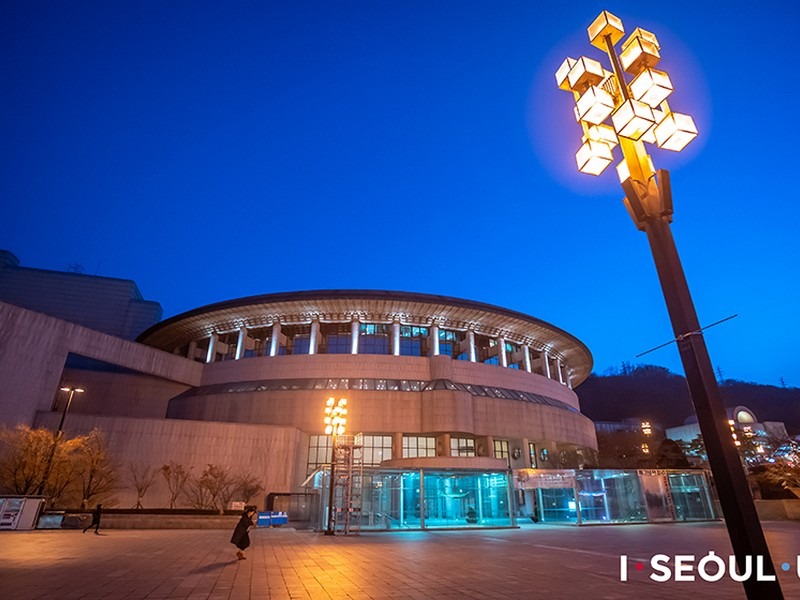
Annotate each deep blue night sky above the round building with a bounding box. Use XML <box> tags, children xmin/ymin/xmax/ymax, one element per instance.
<box><xmin>0</xmin><ymin>0</ymin><xmax>800</xmax><ymax>386</ymax></box>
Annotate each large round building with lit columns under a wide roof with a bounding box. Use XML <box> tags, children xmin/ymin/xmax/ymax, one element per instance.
<box><xmin>138</xmin><ymin>290</ymin><xmax>596</xmax><ymax>476</ymax></box>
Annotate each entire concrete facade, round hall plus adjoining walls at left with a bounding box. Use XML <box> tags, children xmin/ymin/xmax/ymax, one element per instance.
<box><xmin>0</xmin><ymin>280</ymin><xmax>596</xmax><ymax>506</ymax></box>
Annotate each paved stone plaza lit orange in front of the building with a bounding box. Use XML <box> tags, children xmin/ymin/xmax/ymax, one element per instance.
<box><xmin>0</xmin><ymin>522</ymin><xmax>800</xmax><ymax>600</ymax></box>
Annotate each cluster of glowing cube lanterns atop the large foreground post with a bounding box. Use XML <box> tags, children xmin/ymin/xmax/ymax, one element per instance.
<box><xmin>556</xmin><ymin>11</ymin><xmax>697</xmax><ymax>177</ymax></box>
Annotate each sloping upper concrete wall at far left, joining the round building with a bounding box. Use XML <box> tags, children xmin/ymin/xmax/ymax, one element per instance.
<box><xmin>0</xmin><ymin>302</ymin><xmax>203</xmax><ymax>426</ymax></box>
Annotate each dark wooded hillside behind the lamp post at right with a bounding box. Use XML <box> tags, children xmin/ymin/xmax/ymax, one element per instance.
<box><xmin>575</xmin><ymin>365</ymin><xmax>800</xmax><ymax>435</ymax></box>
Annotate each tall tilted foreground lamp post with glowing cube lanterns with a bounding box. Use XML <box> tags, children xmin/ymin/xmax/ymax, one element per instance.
<box><xmin>556</xmin><ymin>11</ymin><xmax>783</xmax><ymax>600</ymax></box>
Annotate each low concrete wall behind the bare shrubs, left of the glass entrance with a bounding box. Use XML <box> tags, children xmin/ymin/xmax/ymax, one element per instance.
<box><xmin>35</xmin><ymin>412</ymin><xmax>308</xmax><ymax>509</ymax></box>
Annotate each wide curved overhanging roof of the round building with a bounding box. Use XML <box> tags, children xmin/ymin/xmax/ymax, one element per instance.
<box><xmin>137</xmin><ymin>290</ymin><xmax>592</xmax><ymax>384</ymax></box>
